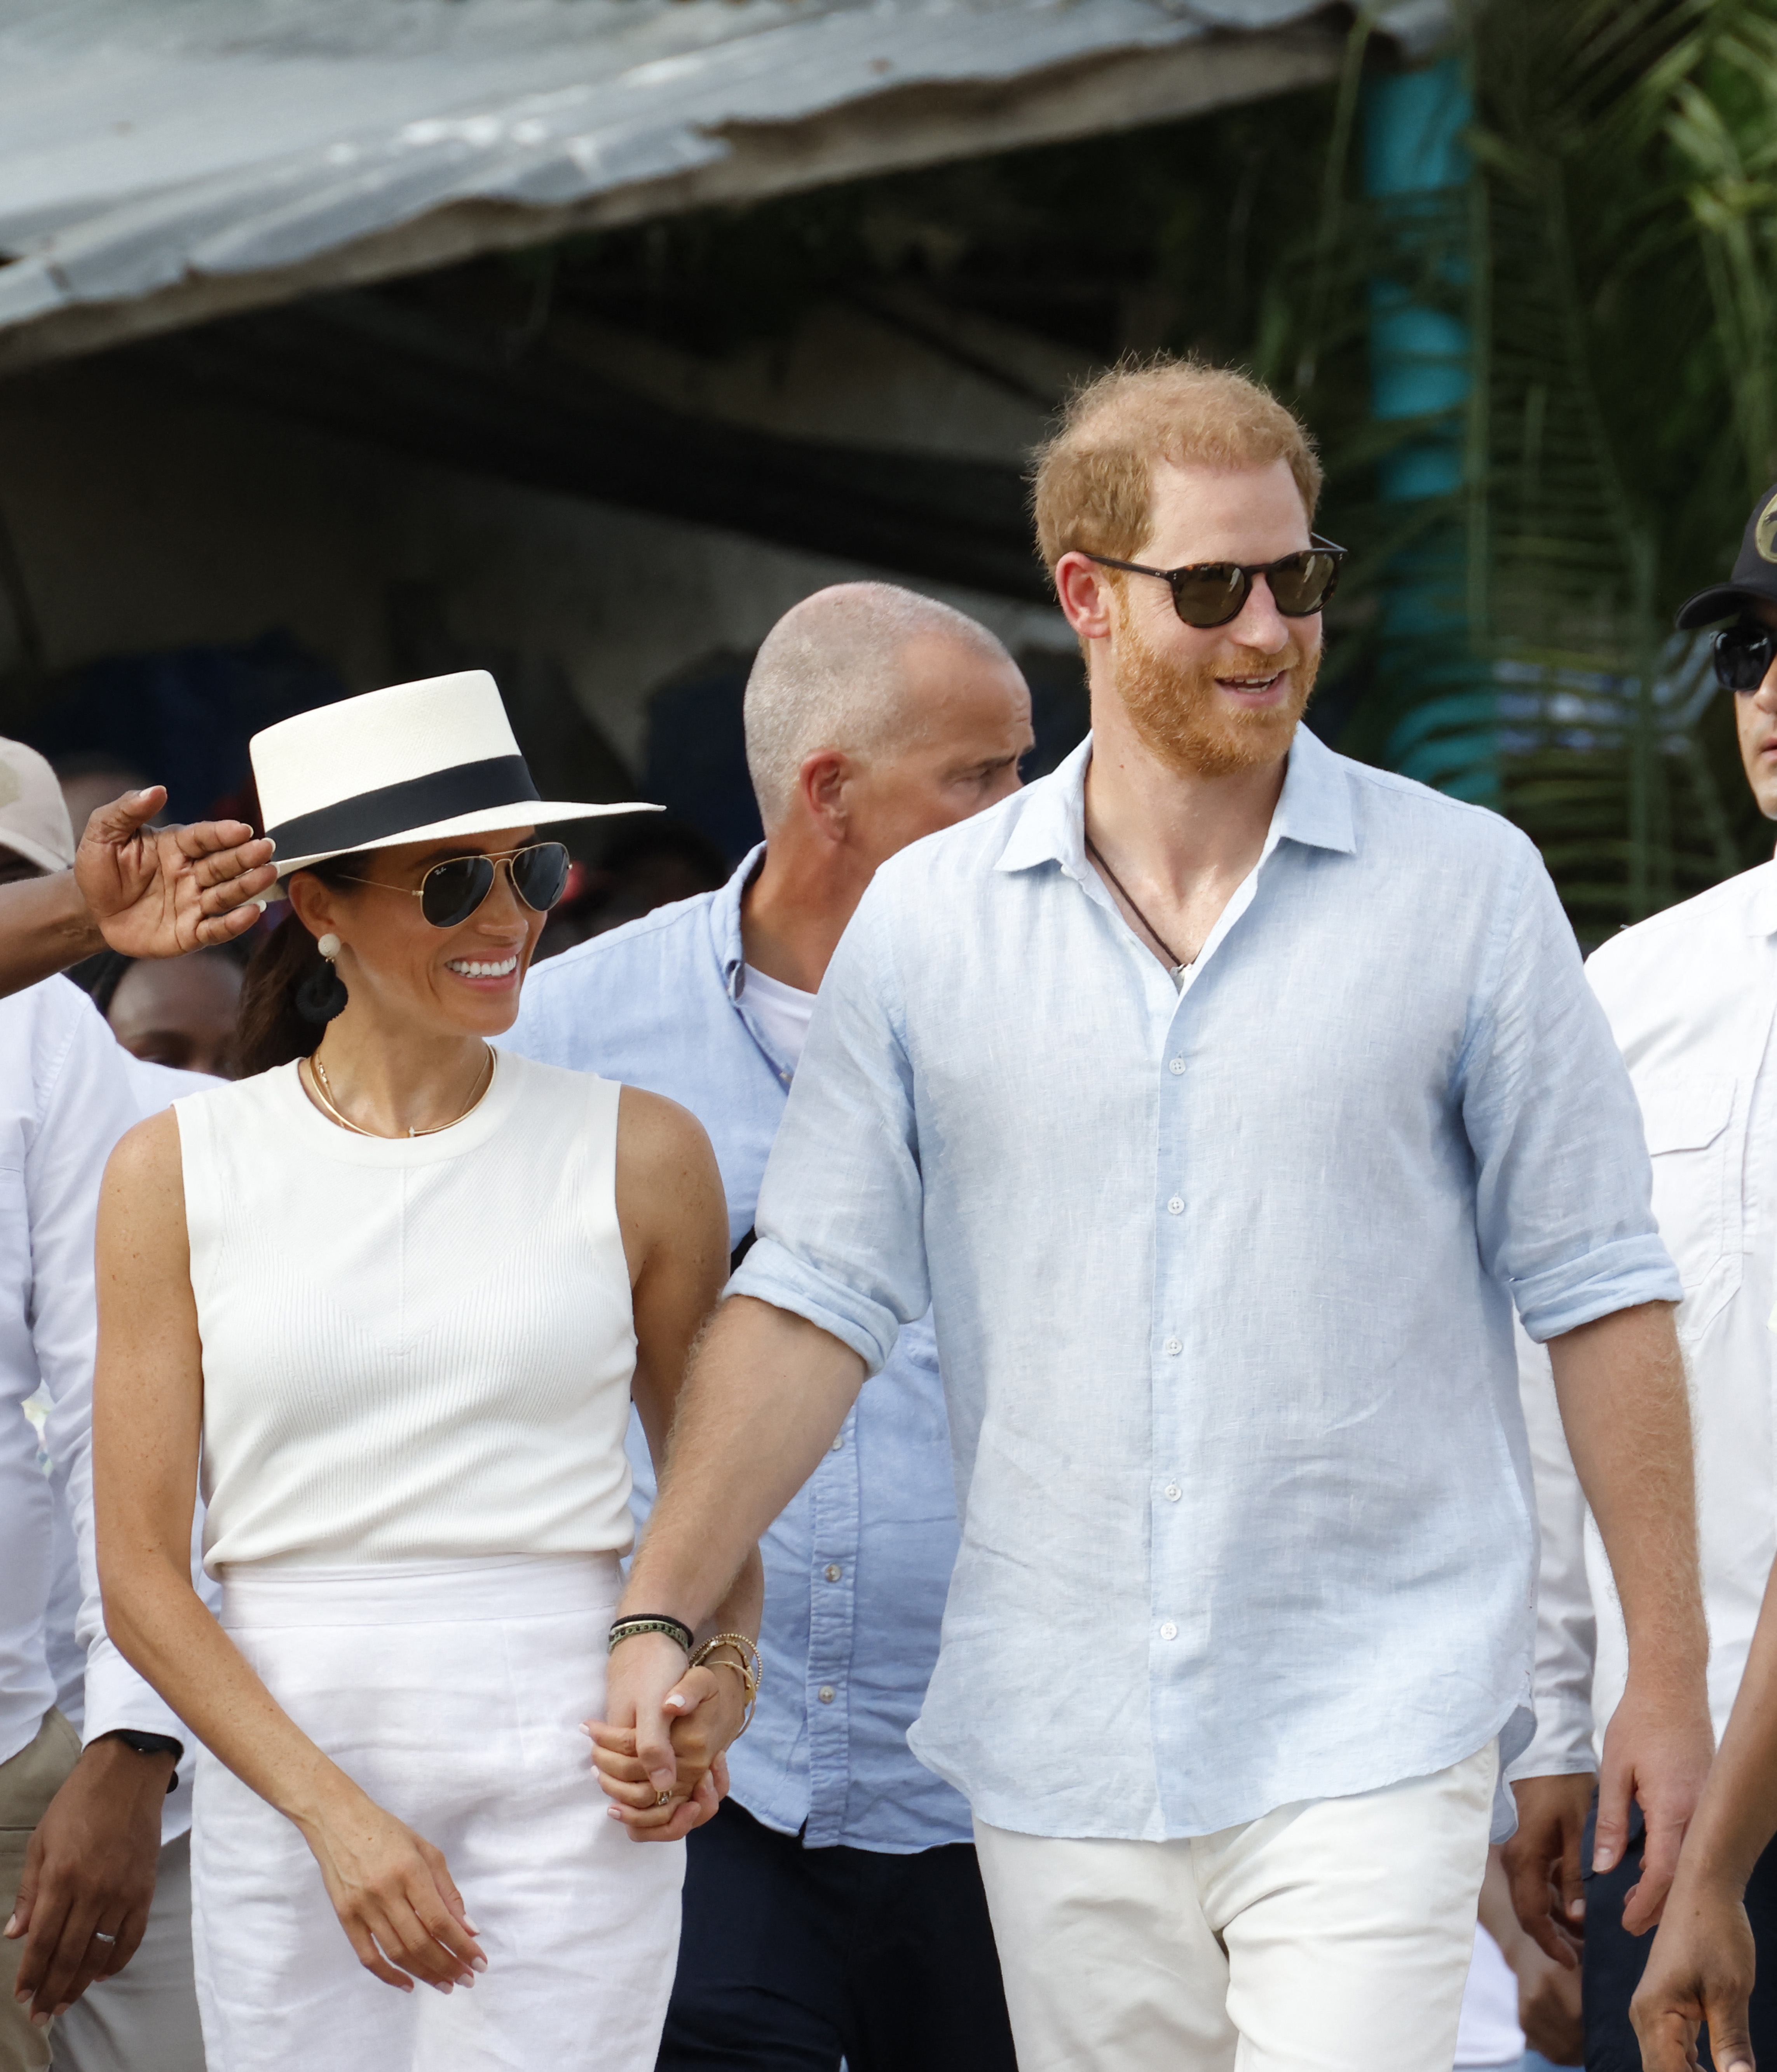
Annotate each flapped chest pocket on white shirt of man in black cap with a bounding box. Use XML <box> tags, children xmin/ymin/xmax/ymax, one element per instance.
<box><xmin>1638</xmin><ymin>1073</ymin><xmax>1742</xmax><ymax>1338</ymax></box>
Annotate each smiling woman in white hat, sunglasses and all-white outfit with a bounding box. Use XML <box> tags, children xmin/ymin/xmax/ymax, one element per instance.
<box><xmin>85</xmin><ymin>671</ymin><xmax>759</xmax><ymax>2072</ymax></box>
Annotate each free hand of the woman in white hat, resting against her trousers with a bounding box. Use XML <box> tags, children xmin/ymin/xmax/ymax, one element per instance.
<box><xmin>296</xmin><ymin>1788</ymin><xmax>487</xmax><ymax>1993</ymax></box>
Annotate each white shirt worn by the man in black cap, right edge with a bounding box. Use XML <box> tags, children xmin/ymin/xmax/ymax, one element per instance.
<box><xmin>1512</xmin><ymin>864</ymin><xmax>1777</xmax><ymax>1778</ymax></box>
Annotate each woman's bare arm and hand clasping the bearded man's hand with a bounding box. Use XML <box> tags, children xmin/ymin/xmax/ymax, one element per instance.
<box><xmin>591</xmin><ymin>1086</ymin><xmax>765</xmax><ymax>1842</ymax></box>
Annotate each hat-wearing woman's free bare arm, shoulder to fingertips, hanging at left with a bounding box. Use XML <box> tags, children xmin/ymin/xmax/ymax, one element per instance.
<box><xmin>93</xmin><ymin>1110</ymin><xmax>485</xmax><ymax>1991</ymax></box>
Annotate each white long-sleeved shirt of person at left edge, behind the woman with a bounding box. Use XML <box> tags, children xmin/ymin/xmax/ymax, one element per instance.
<box><xmin>0</xmin><ymin>978</ymin><xmax>191</xmax><ymax>1761</ymax></box>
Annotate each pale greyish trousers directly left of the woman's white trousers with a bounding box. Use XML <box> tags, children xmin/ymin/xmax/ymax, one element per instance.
<box><xmin>52</xmin><ymin>1834</ymin><xmax>203</xmax><ymax>2072</ymax></box>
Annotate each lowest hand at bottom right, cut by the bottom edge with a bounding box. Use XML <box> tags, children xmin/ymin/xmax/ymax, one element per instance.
<box><xmin>1630</xmin><ymin>1869</ymin><xmax>1754</xmax><ymax>2072</ymax></box>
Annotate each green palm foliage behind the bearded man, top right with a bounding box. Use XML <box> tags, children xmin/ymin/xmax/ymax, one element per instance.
<box><xmin>1298</xmin><ymin>0</ymin><xmax>1777</xmax><ymax>939</ymax></box>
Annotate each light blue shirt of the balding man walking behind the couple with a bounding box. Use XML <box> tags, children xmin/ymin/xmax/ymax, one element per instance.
<box><xmin>502</xmin><ymin>847</ymin><xmax>973</xmax><ymax>1854</ymax></box>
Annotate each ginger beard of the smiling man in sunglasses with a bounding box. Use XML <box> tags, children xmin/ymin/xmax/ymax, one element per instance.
<box><xmin>1116</xmin><ymin>622</ymin><xmax>1321</xmax><ymax>777</ymax></box>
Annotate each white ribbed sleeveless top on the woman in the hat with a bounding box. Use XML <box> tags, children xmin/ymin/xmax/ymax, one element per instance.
<box><xmin>174</xmin><ymin>1051</ymin><xmax>635</xmax><ymax>1575</ymax></box>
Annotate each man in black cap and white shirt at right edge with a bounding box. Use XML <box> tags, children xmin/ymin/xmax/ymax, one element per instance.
<box><xmin>1505</xmin><ymin>485</ymin><xmax>1777</xmax><ymax>2072</ymax></box>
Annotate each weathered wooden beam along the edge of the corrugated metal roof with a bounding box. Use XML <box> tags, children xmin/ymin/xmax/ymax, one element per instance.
<box><xmin>0</xmin><ymin>29</ymin><xmax>1344</xmax><ymax>373</ymax></box>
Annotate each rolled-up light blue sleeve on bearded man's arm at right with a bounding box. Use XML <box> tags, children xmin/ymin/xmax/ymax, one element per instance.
<box><xmin>1462</xmin><ymin>841</ymin><xmax>1684</xmax><ymax>1345</ymax></box>
